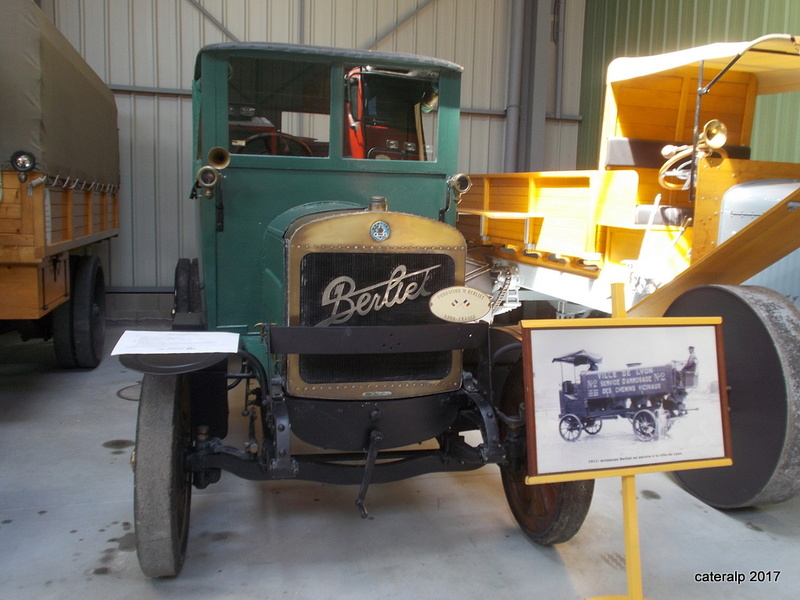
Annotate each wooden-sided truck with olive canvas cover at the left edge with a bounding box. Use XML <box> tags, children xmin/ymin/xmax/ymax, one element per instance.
<box><xmin>0</xmin><ymin>2</ymin><xmax>119</xmax><ymax>368</ymax></box>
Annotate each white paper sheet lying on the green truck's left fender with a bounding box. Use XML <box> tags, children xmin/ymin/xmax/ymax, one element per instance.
<box><xmin>111</xmin><ymin>330</ymin><xmax>239</xmax><ymax>356</ymax></box>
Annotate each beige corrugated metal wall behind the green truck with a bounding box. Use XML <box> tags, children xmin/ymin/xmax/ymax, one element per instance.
<box><xmin>37</xmin><ymin>0</ymin><xmax>511</xmax><ymax>291</ymax></box>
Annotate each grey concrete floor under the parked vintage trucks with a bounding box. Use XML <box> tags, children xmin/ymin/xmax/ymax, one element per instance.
<box><xmin>0</xmin><ymin>328</ymin><xmax>800</xmax><ymax>600</ymax></box>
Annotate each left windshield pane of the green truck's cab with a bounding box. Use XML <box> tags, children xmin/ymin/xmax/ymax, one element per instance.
<box><xmin>228</xmin><ymin>57</ymin><xmax>331</xmax><ymax>157</ymax></box>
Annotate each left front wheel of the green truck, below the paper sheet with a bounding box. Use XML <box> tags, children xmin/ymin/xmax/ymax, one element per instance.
<box><xmin>133</xmin><ymin>375</ymin><xmax>192</xmax><ymax>577</ymax></box>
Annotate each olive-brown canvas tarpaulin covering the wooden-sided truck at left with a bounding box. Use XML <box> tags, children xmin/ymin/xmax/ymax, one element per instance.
<box><xmin>0</xmin><ymin>0</ymin><xmax>119</xmax><ymax>184</ymax></box>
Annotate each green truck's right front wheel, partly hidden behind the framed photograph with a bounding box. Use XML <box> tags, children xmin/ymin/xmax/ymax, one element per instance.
<box><xmin>500</xmin><ymin>362</ymin><xmax>594</xmax><ymax>546</ymax></box>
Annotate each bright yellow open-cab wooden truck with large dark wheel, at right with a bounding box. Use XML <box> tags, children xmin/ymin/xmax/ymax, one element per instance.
<box><xmin>458</xmin><ymin>34</ymin><xmax>800</xmax><ymax>507</ymax></box>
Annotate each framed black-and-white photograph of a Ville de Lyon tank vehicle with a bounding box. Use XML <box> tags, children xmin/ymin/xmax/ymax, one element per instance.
<box><xmin>522</xmin><ymin>318</ymin><xmax>730</xmax><ymax>476</ymax></box>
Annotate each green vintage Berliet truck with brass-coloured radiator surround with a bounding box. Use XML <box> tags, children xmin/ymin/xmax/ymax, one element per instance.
<box><xmin>122</xmin><ymin>43</ymin><xmax>593</xmax><ymax>577</ymax></box>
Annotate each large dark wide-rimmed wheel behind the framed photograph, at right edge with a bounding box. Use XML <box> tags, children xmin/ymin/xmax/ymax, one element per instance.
<box><xmin>665</xmin><ymin>285</ymin><xmax>800</xmax><ymax>508</ymax></box>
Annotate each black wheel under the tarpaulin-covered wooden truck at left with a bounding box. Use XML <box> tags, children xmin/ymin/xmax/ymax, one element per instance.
<box><xmin>52</xmin><ymin>256</ymin><xmax>106</xmax><ymax>369</ymax></box>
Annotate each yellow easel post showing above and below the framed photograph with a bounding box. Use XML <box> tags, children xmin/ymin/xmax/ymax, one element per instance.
<box><xmin>592</xmin><ymin>283</ymin><xmax>645</xmax><ymax>600</ymax></box>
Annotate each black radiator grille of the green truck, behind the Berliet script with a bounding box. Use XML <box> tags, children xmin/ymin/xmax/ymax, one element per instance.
<box><xmin>299</xmin><ymin>252</ymin><xmax>455</xmax><ymax>384</ymax></box>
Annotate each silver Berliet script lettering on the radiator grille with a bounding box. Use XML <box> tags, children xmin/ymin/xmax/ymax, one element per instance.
<box><xmin>316</xmin><ymin>265</ymin><xmax>441</xmax><ymax>327</ymax></box>
